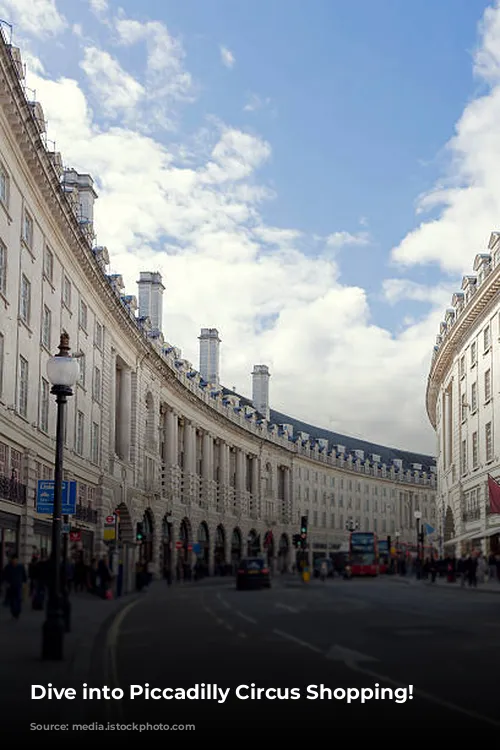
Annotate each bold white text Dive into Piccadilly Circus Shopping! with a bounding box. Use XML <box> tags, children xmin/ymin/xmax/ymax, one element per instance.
<box><xmin>31</xmin><ymin>682</ymin><xmax>413</xmax><ymax>703</ymax></box>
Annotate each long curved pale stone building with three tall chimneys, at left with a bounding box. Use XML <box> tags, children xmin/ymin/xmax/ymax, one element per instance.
<box><xmin>0</xmin><ymin>42</ymin><xmax>435</xmax><ymax>587</ymax></box>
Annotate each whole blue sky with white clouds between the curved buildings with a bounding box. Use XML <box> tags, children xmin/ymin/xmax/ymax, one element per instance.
<box><xmin>0</xmin><ymin>0</ymin><xmax>500</xmax><ymax>454</ymax></box>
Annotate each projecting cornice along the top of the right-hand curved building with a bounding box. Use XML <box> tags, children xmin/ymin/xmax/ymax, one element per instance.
<box><xmin>426</xmin><ymin>265</ymin><xmax>500</xmax><ymax>429</ymax></box>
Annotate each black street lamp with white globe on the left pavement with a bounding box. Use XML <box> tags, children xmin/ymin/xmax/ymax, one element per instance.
<box><xmin>42</xmin><ymin>333</ymin><xmax>80</xmax><ymax>661</ymax></box>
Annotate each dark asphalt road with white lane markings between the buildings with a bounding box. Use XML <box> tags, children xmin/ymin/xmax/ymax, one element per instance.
<box><xmin>81</xmin><ymin>579</ymin><xmax>500</xmax><ymax>735</ymax></box>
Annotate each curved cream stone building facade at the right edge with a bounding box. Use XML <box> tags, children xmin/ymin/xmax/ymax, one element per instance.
<box><xmin>427</xmin><ymin>232</ymin><xmax>500</xmax><ymax>553</ymax></box>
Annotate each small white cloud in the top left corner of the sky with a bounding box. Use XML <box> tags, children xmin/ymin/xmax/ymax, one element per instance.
<box><xmin>0</xmin><ymin>0</ymin><xmax>67</xmax><ymax>39</ymax></box>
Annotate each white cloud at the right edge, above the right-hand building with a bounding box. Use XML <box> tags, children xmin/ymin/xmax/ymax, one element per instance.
<box><xmin>392</xmin><ymin>2</ymin><xmax>500</xmax><ymax>273</ymax></box>
